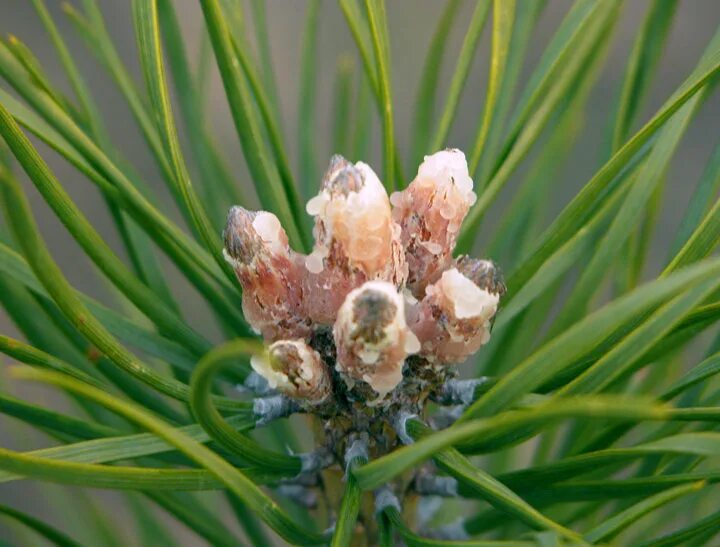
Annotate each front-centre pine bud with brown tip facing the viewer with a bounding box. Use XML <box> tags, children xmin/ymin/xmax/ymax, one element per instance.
<box><xmin>333</xmin><ymin>281</ymin><xmax>419</xmax><ymax>401</ymax></box>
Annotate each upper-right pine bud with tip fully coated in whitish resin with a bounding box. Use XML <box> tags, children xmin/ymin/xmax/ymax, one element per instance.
<box><xmin>390</xmin><ymin>149</ymin><xmax>476</xmax><ymax>298</ymax></box>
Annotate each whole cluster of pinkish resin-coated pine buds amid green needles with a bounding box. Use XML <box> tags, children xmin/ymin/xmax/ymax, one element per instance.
<box><xmin>224</xmin><ymin>150</ymin><xmax>505</xmax><ymax>454</ymax></box>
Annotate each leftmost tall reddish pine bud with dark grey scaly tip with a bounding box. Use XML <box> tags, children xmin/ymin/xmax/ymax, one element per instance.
<box><xmin>223</xmin><ymin>207</ymin><xmax>310</xmax><ymax>340</ymax></box>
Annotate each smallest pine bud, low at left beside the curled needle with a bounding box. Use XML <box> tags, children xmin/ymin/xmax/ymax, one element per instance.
<box><xmin>250</xmin><ymin>340</ymin><xmax>332</xmax><ymax>405</ymax></box>
